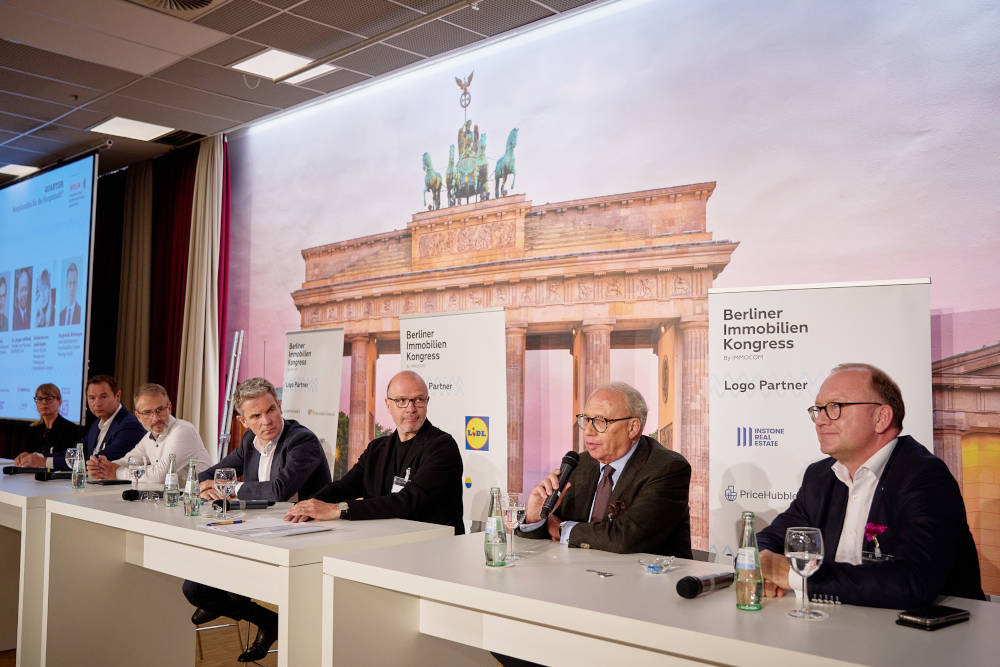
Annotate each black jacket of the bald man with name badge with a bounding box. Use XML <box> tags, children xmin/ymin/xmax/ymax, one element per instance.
<box><xmin>315</xmin><ymin>420</ymin><xmax>465</xmax><ymax>535</ymax></box>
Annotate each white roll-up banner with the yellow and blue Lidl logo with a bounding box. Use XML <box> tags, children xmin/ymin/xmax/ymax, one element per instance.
<box><xmin>399</xmin><ymin>308</ymin><xmax>507</xmax><ymax>526</ymax></box>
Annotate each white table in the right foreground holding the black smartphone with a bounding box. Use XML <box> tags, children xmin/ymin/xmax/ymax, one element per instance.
<box><xmin>323</xmin><ymin>534</ymin><xmax>1000</xmax><ymax>667</ymax></box>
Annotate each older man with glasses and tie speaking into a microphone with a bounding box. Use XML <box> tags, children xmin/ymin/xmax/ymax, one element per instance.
<box><xmin>519</xmin><ymin>382</ymin><xmax>691</xmax><ymax>558</ymax></box>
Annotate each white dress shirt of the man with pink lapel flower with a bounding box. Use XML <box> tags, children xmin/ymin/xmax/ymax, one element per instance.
<box><xmin>788</xmin><ymin>438</ymin><xmax>897</xmax><ymax>593</ymax></box>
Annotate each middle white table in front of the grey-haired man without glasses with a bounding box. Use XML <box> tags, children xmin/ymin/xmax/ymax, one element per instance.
<box><xmin>40</xmin><ymin>496</ymin><xmax>454</xmax><ymax>667</ymax></box>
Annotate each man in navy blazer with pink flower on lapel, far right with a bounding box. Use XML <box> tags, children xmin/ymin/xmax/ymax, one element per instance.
<box><xmin>757</xmin><ymin>364</ymin><xmax>985</xmax><ymax>608</ymax></box>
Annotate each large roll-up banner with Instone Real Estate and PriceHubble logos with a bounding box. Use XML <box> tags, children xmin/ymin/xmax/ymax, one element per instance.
<box><xmin>708</xmin><ymin>279</ymin><xmax>934</xmax><ymax>554</ymax></box>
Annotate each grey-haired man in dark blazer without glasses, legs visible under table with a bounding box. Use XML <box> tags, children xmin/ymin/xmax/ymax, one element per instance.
<box><xmin>183</xmin><ymin>378</ymin><xmax>330</xmax><ymax>662</ymax></box>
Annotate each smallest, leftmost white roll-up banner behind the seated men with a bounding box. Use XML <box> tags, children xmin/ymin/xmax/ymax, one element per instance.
<box><xmin>281</xmin><ymin>327</ymin><xmax>344</xmax><ymax>470</ymax></box>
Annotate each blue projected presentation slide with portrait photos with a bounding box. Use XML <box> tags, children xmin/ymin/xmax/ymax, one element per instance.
<box><xmin>0</xmin><ymin>156</ymin><xmax>97</xmax><ymax>421</ymax></box>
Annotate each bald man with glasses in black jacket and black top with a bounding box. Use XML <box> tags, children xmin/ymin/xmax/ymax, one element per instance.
<box><xmin>285</xmin><ymin>371</ymin><xmax>465</xmax><ymax>535</ymax></box>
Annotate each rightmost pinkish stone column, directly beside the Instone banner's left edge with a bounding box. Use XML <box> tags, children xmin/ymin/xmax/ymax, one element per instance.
<box><xmin>675</xmin><ymin>320</ymin><xmax>708</xmax><ymax>549</ymax></box>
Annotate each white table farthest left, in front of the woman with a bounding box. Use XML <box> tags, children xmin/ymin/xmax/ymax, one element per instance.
<box><xmin>0</xmin><ymin>459</ymin><xmax>122</xmax><ymax>666</ymax></box>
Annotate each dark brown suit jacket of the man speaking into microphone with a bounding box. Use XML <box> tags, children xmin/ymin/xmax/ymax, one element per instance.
<box><xmin>524</xmin><ymin>435</ymin><xmax>691</xmax><ymax>558</ymax></box>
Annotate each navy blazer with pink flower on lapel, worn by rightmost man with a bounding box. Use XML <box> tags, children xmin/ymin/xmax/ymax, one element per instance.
<box><xmin>757</xmin><ymin>435</ymin><xmax>984</xmax><ymax>609</ymax></box>
